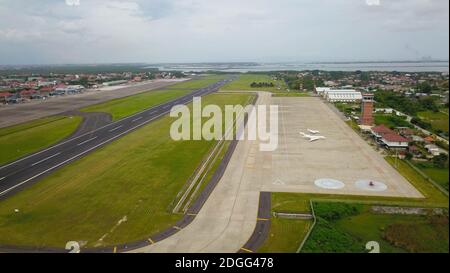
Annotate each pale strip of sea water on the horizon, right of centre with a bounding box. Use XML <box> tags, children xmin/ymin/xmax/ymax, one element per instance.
<box><xmin>148</xmin><ymin>61</ymin><xmax>449</xmax><ymax>72</ymax></box>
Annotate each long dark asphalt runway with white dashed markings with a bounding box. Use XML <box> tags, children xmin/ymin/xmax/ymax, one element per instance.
<box><xmin>0</xmin><ymin>79</ymin><xmax>231</xmax><ymax>199</ymax></box>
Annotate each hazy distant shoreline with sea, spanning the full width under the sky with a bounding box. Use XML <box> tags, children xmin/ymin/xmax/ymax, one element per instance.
<box><xmin>0</xmin><ymin>60</ymin><xmax>449</xmax><ymax>74</ymax></box>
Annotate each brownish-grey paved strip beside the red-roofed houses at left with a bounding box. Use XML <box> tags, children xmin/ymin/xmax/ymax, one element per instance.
<box><xmin>0</xmin><ymin>80</ymin><xmax>186</xmax><ymax>128</ymax></box>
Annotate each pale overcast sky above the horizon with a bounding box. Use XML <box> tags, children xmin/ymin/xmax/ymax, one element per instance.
<box><xmin>0</xmin><ymin>0</ymin><xmax>449</xmax><ymax>64</ymax></box>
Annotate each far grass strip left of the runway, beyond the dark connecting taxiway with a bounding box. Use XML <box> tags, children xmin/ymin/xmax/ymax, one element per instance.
<box><xmin>81</xmin><ymin>89</ymin><xmax>192</xmax><ymax>120</ymax></box>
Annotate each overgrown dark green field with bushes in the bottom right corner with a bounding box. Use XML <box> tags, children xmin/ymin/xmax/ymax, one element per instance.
<box><xmin>304</xmin><ymin>203</ymin><xmax>448</xmax><ymax>253</ymax></box>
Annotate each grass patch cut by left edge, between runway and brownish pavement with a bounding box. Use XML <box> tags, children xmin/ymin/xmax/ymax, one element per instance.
<box><xmin>0</xmin><ymin>116</ymin><xmax>82</xmax><ymax>165</ymax></box>
